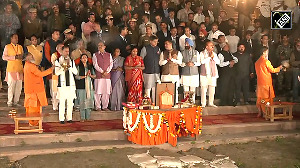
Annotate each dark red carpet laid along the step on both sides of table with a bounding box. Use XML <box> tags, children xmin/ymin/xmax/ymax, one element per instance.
<box><xmin>0</xmin><ymin>113</ymin><xmax>300</xmax><ymax>136</ymax></box>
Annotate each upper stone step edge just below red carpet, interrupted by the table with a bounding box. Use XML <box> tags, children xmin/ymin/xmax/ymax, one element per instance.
<box><xmin>0</xmin><ymin>120</ymin><xmax>300</xmax><ymax>149</ymax></box>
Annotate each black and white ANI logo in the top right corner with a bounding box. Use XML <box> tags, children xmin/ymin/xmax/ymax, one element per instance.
<box><xmin>271</xmin><ymin>11</ymin><xmax>292</xmax><ymax>30</ymax></box>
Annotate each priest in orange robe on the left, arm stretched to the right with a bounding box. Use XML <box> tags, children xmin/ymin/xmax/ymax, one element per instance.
<box><xmin>24</xmin><ymin>53</ymin><xmax>53</xmax><ymax>126</ymax></box>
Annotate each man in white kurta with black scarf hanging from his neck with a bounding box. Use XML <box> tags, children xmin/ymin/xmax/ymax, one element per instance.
<box><xmin>55</xmin><ymin>46</ymin><xmax>78</xmax><ymax>124</ymax></box>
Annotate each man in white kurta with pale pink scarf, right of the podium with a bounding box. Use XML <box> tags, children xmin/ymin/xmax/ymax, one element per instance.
<box><xmin>200</xmin><ymin>42</ymin><xmax>220</xmax><ymax>107</ymax></box>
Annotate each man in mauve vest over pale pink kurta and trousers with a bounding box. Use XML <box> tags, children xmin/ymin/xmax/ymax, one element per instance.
<box><xmin>93</xmin><ymin>42</ymin><xmax>113</xmax><ymax>111</ymax></box>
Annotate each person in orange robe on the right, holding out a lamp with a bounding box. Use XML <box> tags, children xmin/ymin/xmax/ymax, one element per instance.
<box><xmin>255</xmin><ymin>47</ymin><xmax>282</xmax><ymax>117</ymax></box>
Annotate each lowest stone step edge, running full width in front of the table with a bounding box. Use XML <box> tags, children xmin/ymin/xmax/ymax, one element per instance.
<box><xmin>0</xmin><ymin>130</ymin><xmax>300</xmax><ymax>161</ymax></box>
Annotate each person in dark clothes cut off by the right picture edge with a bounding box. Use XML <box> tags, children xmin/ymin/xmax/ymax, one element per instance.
<box><xmin>290</xmin><ymin>41</ymin><xmax>300</xmax><ymax>102</ymax></box>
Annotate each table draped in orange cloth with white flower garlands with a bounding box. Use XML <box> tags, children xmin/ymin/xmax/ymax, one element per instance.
<box><xmin>123</xmin><ymin>106</ymin><xmax>202</xmax><ymax>146</ymax></box>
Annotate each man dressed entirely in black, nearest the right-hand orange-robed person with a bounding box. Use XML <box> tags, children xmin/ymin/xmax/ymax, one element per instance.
<box><xmin>234</xmin><ymin>44</ymin><xmax>254</xmax><ymax>105</ymax></box>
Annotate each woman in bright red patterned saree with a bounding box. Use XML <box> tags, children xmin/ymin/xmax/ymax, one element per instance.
<box><xmin>124</xmin><ymin>48</ymin><xmax>145</xmax><ymax>103</ymax></box>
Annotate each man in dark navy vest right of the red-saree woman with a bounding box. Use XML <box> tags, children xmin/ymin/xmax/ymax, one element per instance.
<box><xmin>140</xmin><ymin>35</ymin><xmax>160</xmax><ymax>102</ymax></box>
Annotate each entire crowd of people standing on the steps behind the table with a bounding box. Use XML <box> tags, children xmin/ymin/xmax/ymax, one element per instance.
<box><xmin>0</xmin><ymin>0</ymin><xmax>300</xmax><ymax>125</ymax></box>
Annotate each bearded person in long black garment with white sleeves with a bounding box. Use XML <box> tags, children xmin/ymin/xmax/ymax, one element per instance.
<box><xmin>217</xmin><ymin>43</ymin><xmax>238</xmax><ymax>106</ymax></box>
